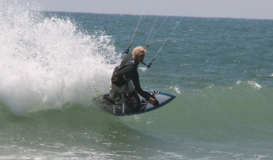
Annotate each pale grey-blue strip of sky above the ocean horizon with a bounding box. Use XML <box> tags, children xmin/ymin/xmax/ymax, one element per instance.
<box><xmin>31</xmin><ymin>0</ymin><xmax>273</xmax><ymax>19</ymax></box>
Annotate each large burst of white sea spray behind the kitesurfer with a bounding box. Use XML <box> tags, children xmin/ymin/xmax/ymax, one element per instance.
<box><xmin>0</xmin><ymin>1</ymin><xmax>120</xmax><ymax>114</ymax></box>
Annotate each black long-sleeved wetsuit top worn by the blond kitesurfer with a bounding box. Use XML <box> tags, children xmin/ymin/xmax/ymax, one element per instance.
<box><xmin>112</xmin><ymin>54</ymin><xmax>152</xmax><ymax>100</ymax></box>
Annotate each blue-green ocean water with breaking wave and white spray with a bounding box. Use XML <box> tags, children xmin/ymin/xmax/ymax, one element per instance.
<box><xmin>0</xmin><ymin>0</ymin><xmax>273</xmax><ymax>160</ymax></box>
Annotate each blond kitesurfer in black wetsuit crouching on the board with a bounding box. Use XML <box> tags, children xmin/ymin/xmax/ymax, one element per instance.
<box><xmin>110</xmin><ymin>46</ymin><xmax>155</xmax><ymax>107</ymax></box>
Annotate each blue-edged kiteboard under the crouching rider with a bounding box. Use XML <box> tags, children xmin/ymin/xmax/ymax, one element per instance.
<box><xmin>93</xmin><ymin>90</ymin><xmax>176</xmax><ymax>116</ymax></box>
